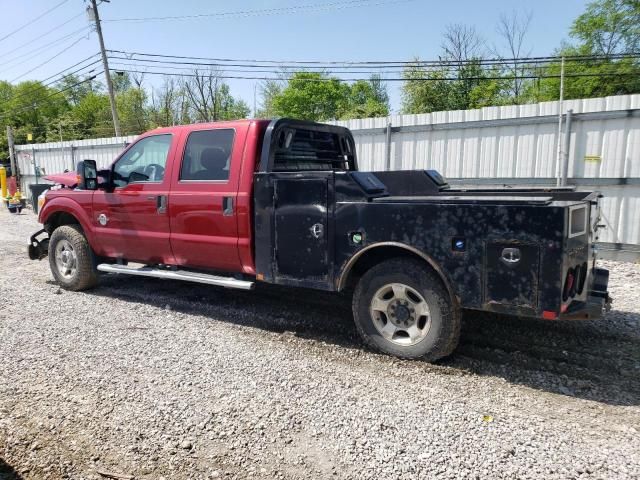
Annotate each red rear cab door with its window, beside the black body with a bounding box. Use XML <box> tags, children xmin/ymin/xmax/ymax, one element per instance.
<box><xmin>169</xmin><ymin>125</ymin><xmax>247</xmax><ymax>272</ymax></box>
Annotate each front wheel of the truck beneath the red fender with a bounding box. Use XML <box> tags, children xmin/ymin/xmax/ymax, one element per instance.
<box><xmin>49</xmin><ymin>225</ymin><xmax>98</xmax><ymax>291</ymax></box>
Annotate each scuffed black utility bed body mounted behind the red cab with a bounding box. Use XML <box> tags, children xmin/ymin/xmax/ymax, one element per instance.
<box><xmin>254</xmin><ymin>121</ymin><xmax>608</xmax><ymax>319</ymax></box>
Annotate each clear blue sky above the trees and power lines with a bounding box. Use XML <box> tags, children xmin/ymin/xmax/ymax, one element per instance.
<box><xmin>0</xmin><ymin>0</ymin><xmax>587</xmax><ymax>110</ymax></box>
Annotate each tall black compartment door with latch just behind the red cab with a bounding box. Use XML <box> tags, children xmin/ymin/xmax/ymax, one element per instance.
<box><xmin>275</xmin><ymin>172</ymin><xmax>331</xmax><ymax>284</ymax></box>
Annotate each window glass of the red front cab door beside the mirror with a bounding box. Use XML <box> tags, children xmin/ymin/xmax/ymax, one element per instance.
<box><xmin>113</xmin><ymin>134</ymin><xmax>171</xmax><ymax>187</ymax></box>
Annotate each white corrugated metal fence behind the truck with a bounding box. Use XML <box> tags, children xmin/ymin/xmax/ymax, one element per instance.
<box><xmin>16</xmin><ymin>95</ymin><xmax>640</xmax><ymax>249</ymax></box>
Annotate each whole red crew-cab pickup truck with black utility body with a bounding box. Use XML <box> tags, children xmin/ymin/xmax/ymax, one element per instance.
<box><xmin>29</xmin><ymin>119</ymin><xmax>609</xmax><ymax>360</ymax></box>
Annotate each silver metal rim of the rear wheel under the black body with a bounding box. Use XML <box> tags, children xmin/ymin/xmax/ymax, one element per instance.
<box><xmin>370</xmin><ymin>283</ymin><xmax>431</xmax><ymax>347</ymax></box>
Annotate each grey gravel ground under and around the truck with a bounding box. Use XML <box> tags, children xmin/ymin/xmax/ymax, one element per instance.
<box><xmin>0</xmin><ymin>207</ymin><xmax>640</xmax><ymax>479</ymax></box>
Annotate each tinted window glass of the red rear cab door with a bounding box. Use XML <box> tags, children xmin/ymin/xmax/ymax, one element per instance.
<box><xmin>180</xmin><ymin>129</ymin><xmax>235</xmax><ymax>181</ymax></box>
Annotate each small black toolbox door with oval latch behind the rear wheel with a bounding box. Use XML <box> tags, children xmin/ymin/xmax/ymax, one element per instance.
<box><xmin>484</xmin><ymin>241</ymin><xmax>540</xmax><ymax>309</ymax></box>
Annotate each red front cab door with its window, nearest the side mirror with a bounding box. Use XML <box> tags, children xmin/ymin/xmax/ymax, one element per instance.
<box><xmin>92</xmin><ymin>134</ymin><xmax>177</xmax><ymax>264</ymax></box>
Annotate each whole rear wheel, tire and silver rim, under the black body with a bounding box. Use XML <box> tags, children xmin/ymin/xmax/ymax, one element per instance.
<box><xmin>353</xmin><ymin>258</ymin><xmax>460</xmax><ymax>361</ymax></box>
